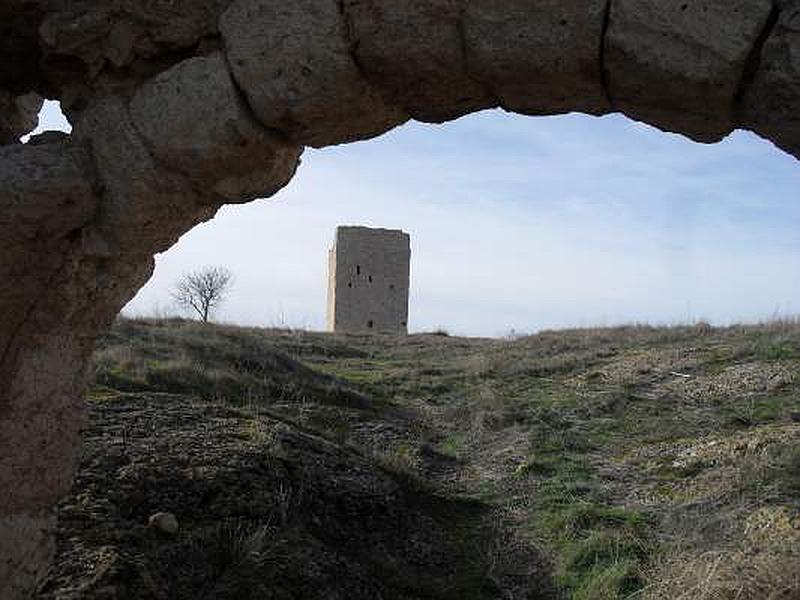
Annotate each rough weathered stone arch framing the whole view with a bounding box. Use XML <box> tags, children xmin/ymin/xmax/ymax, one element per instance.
<box><xmin>0</xmin><ymin>0</ymin><xmax>800</xmax><ymax>599</ymax></box>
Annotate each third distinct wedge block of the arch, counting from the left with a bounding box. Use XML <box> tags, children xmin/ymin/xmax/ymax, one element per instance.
<box><xmin>343</xmin><ymin>0</ymin><xmax>497</xmax><ymax>122</ymax></box>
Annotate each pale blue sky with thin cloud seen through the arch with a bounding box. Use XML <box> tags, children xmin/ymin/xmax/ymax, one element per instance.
<box><xmin>32</xmin><ymin>105</ymin><xmax>800</xmax><ymax>335</ymax></box>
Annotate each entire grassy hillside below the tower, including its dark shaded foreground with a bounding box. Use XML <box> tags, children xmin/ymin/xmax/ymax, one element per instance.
<box><xmin>39</xmin><ymin>320</ymin><xmax>800</xmax><ymax>600</ymax></box>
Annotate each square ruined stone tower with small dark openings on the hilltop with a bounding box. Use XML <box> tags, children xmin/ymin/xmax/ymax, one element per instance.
<box><xmin>328</xmin><ymin>227</ymin><xmax>411</xmax><ymax>334</ymax></box>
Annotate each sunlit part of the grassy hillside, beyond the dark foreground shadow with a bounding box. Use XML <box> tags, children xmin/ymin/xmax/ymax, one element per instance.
<box><xmin>90</xmin><ymin>321</ymin><xmax>800</xmax><ymax>599</ymax></box>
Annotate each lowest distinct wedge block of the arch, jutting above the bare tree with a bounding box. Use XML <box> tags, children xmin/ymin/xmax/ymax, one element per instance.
<box><xmin>131</xmin><ymin>53</ymin><xmax>301</xmax><ymax>202</ymax></box>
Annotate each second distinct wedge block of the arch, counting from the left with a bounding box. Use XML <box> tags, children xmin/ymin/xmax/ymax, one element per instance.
<box><xmin>221</xmin><ymin>0</ymin><xmax>408</xmax><ymax>146</ymax></box>
